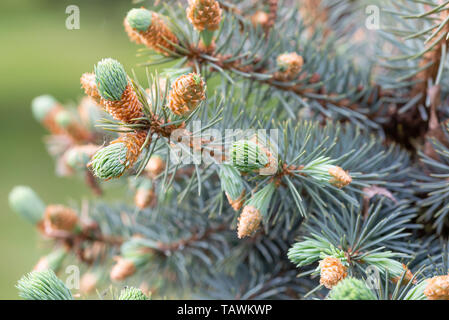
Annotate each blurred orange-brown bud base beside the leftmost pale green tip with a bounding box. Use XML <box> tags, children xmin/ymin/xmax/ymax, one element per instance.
<box><xmin>44</xmin><ymin>204</ymin><xmax>79</xmax><ymax>232</ymax></box>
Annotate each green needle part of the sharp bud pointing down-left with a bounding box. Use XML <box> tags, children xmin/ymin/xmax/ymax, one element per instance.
<box><xmin>89</xmin><ymin>142</ymin><xmax>128</xmax><ymax>179</ymax></box>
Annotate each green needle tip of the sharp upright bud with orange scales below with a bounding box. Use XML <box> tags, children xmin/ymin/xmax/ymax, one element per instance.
<box><xmin>95</xmin><ymin>58</ymin><xmax>128</xmax><ymax>101</ymax></box>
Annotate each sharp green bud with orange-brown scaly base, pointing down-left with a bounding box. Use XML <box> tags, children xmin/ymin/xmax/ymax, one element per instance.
<box><xmin>88</xmin><ymin>131</ymin><xmax>147</xmax><ymax>180</ymax></box>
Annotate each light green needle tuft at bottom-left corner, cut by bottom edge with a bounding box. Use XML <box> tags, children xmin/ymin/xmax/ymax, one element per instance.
<box><xmin>17</xmin><ymin>269</ymin><xmax>73</xmax><ymax>300</ymax></box>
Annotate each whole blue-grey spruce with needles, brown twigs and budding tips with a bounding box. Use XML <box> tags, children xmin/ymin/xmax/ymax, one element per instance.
<box><xmin>14</xmin><ymin>0</ymin><xmax>449</xmax><ymax>300</ymax></box>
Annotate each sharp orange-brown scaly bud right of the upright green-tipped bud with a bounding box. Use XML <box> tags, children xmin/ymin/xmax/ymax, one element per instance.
<box><xmin>168</xmin><ymin>73</ymin><xmax>206</xmax><ymax>116</ymax></box>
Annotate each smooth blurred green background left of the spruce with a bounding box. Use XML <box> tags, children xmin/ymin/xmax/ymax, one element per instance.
<box><xmin>0</xmin><ymin>0</ymin><xmax>149</xmax><ymax>299</ymax></box>
